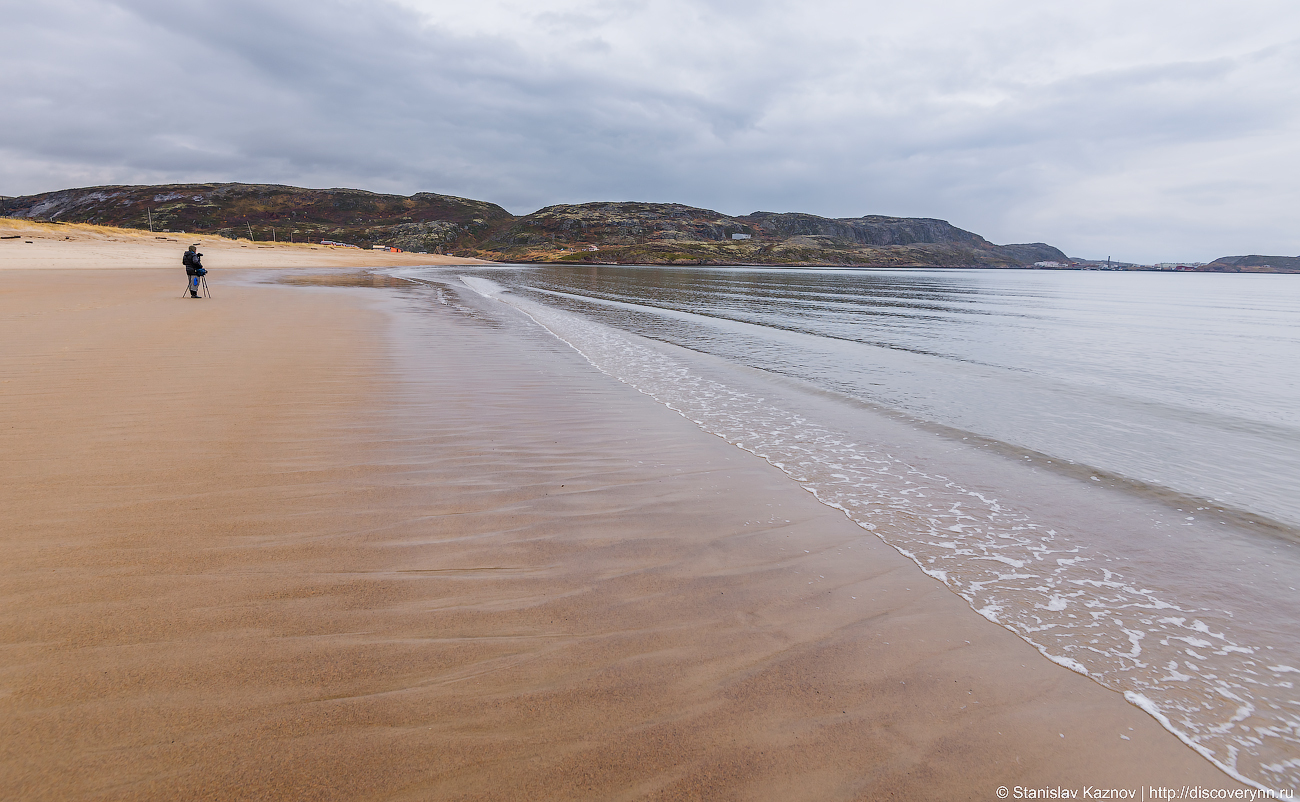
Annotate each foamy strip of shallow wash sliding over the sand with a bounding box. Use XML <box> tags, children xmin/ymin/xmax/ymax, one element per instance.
<box><xmin>462</xmin><ymin>277</ymin><xmax>1300</xmax><ymax>788</ymax></box>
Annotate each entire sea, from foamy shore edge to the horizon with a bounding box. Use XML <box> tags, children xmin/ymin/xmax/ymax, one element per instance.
<box><xmin>403</xmin><ymin>266</ymin><xmax>1300</xmax><ymax>789</ymax></box>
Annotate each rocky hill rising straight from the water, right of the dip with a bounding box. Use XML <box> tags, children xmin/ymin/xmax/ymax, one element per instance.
<box><xmin>467</xmin><ymin>203</ymin><xmax>1066</xmax><ymax>266</ymax></box>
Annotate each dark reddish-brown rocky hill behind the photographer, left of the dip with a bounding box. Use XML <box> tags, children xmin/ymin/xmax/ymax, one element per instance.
<box><xmin>0</xmin><ymin>183</ymin><xmax>514</xmax><ymax>253</ymax></box>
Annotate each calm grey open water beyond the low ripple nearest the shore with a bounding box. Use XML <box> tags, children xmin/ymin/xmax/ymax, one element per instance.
<box><xmin>473</xmin><ymin>266</ymin><xmax>1300</xmax><ymax>528</ymax></box>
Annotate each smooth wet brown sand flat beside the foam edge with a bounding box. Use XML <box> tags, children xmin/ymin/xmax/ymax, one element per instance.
<box><xmin>0</xmin><ymin>254</ymin><xmax>1235</xmax><ymax>799</ymax></box>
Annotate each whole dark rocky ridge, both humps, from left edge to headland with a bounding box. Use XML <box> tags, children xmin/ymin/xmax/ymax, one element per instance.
<box><xmin>0</xmin><ymin>183</ymin><xmax>1067</xmax><ymax>266</ymax></box>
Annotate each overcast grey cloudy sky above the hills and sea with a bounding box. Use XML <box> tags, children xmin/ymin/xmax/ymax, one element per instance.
<box><xmin>0</xmin><ymin>0</ymin><xmax>1300</xmax><ymax>261</ymax></box>
